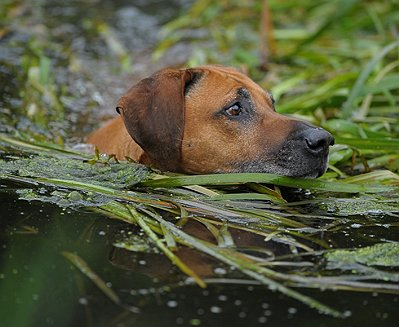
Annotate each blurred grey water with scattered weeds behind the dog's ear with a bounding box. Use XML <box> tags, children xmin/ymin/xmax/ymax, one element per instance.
<box><xmin>0</xmin><ymin>0</ymin><xmax>192</xmax><ymax>138</ymax></box>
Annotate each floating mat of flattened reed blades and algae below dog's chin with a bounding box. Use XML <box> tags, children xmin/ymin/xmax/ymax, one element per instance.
<box><xmin>0</xmin><ymin>136</ymin><xmax>399</xmax><ymax>316</ymax></box>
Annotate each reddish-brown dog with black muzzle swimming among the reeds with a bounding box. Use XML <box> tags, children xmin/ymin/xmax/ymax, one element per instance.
<box><xmin>88</xmin><ymin>66</ymin><xmax>334</xmax><ymax>178</ymax></box>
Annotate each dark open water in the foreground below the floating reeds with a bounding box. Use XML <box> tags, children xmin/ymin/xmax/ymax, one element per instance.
<box><xmin>0</xmin><ymin>185</ymin><xmax>399</xmax><ymax>327</ymax></box>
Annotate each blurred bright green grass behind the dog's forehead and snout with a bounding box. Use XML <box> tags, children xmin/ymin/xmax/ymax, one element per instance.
<box><xmin>155</xmin><ymin>0</ymin><xmax>399</xmax><ymax>175</ymax></box>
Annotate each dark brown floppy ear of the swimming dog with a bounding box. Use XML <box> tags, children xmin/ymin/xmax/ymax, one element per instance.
<box><xmin>116</xmin><ymin>69</ymin><xmax>202</xmax><ymax>171</ymax></box>
